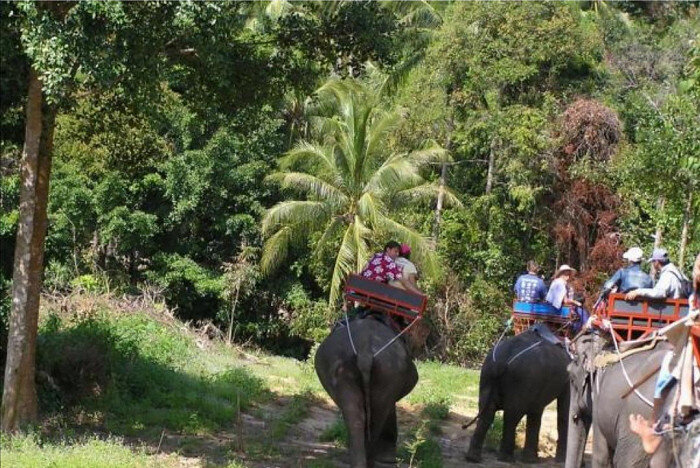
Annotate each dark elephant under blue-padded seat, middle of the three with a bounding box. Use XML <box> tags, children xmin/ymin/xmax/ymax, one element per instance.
<box><xmin>466</xmin><ymin>329</ymin><xmax>570</xmax><ymax>462</ymax></box>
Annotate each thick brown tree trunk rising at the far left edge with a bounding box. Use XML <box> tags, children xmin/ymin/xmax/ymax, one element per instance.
<box><xmin>2</xmin><ymin>70</ymin><xmax>56</xmax><ymax>432</ymax></box>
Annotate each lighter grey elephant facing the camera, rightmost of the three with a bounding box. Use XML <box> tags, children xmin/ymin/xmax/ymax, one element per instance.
<box><xmin>565</xmin><ymin>332</ymin><xmax>670</xmax><ymax>468</ymax></box>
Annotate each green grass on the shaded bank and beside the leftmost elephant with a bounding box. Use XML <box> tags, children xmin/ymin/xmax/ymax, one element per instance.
<box><xmin>21</xmin><ymin>296</ymin><xmax>490</xmax><ymax>468</ymax></box>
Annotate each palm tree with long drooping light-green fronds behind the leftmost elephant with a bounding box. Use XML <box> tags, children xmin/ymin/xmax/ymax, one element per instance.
<box><xmin>261</xmin><ymin>79</ymin><xmax>459</xmax><ymax>304</ymax></box>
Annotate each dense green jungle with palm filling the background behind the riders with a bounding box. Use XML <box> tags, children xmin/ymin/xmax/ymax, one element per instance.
<box><xmin>0</xmin><ymin>1</ymin><xmax>700</xmax><ymax>365</ymax></box>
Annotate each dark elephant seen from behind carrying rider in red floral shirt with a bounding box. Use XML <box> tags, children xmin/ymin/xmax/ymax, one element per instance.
<box><xmin>315</xmin><ymin>316</ymin><xmax>418</xmax><ymax>468</ymax></box>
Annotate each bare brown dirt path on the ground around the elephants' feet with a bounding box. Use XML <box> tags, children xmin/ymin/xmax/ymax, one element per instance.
<box><xmin>153</xmin><ymin>399</ymin><xmax>592</xmax><ymax>468</ymax></box>
